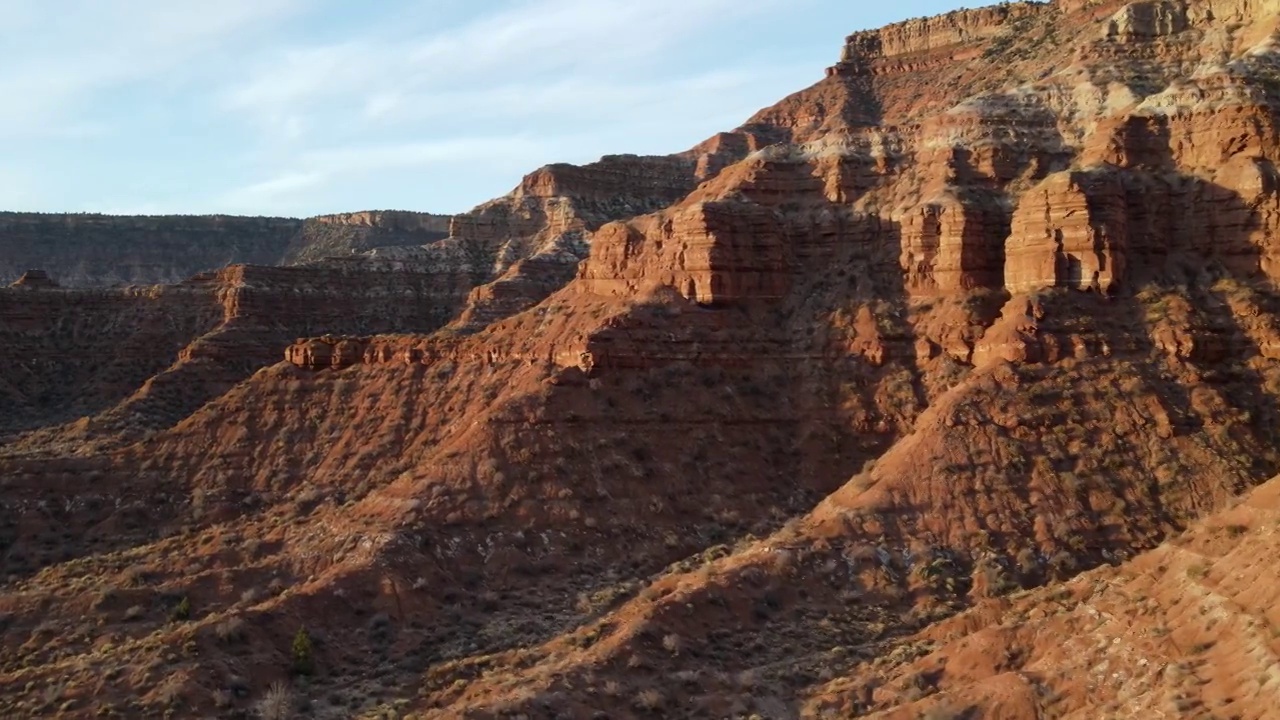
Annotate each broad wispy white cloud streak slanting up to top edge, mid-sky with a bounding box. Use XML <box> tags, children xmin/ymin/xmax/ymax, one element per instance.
<box><xmin>220</xmin><ymin>0</ymin><xmax>781</xmax><ymax>133</ymax></box>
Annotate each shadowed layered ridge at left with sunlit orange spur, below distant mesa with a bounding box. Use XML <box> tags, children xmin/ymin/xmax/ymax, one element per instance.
<box><xmin>0</xmin><ymin>265</ymin><xmax>472</xmax><ymax>443</ymax></box>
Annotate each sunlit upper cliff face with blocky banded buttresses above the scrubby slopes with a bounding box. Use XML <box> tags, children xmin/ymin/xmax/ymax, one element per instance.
<box><xmin>570</xmin><ymin>1</ymin><xmax>1280</xmax><ymax>300</ymax></box>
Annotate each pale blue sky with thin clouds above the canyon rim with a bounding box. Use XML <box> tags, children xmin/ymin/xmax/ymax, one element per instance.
<box><xmin>0</xmin><ymin>0</ymin><xmax>957</xmax><ymax>217</ymax></box>
